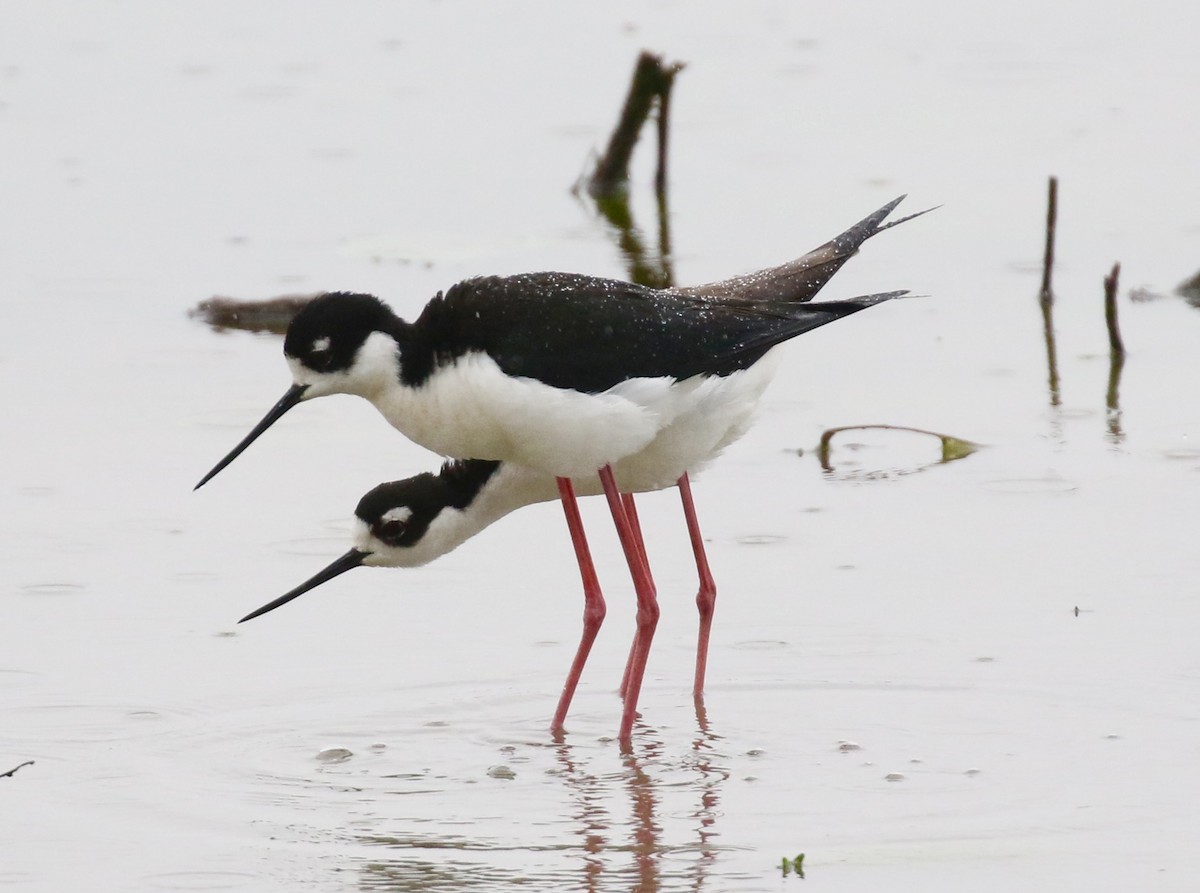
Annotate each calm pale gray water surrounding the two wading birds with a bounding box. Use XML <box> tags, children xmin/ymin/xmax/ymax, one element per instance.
<box><xmin>0</xmin><ymin>0</ymin><xmax>1200</xmax><ymax>893</ymax></box>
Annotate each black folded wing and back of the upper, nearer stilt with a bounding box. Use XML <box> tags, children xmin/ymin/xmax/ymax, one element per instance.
<box><xmin>401</xmin><ymin>272</ymin><xmax>894</xmax><ymax>394</ymax></box>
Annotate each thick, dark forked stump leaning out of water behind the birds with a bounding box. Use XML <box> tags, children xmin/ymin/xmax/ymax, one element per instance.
<box><xmin>587</xmin><ymin>52</ymin><xmax>684</xmax><ymax>198</ymax></box>
